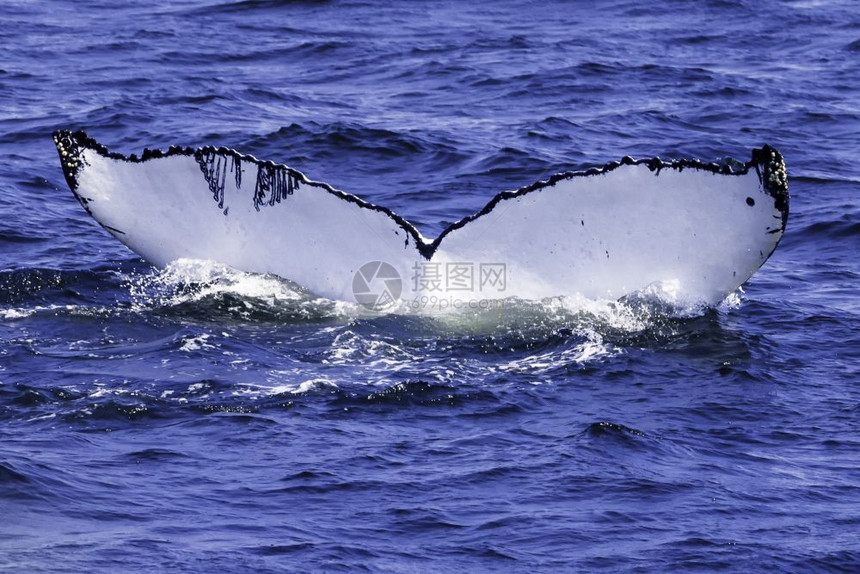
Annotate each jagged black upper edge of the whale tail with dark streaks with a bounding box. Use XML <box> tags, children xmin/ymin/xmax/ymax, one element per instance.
<box><xmin>54</xmin><ymin>130</ymin><xmax>789</xmax><ymax>259</ymax></box>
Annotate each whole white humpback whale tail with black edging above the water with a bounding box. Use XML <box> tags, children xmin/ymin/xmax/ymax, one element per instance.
<box><xmin>54</xmin><ymin>131</ymin><xmax>789</xmax><ymax>310</ymax></box>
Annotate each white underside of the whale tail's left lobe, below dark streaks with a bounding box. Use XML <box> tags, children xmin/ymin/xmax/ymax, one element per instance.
<box><xmin>78</xmin><ymin>150</ymin><xmax>421</xmax><ymax>306</ymax></box>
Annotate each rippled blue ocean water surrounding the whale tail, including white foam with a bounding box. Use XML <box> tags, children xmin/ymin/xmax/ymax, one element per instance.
<box><xmin>0</xmin><ymin>0</ymin><xmax>860</xmax><ymax>573</ymax></box>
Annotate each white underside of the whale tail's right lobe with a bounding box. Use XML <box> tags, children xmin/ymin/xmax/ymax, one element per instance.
<box><xmin>440</xmin><ymin>165</ymin><xmax>781</xmax><ymax>303</ymax></box>
